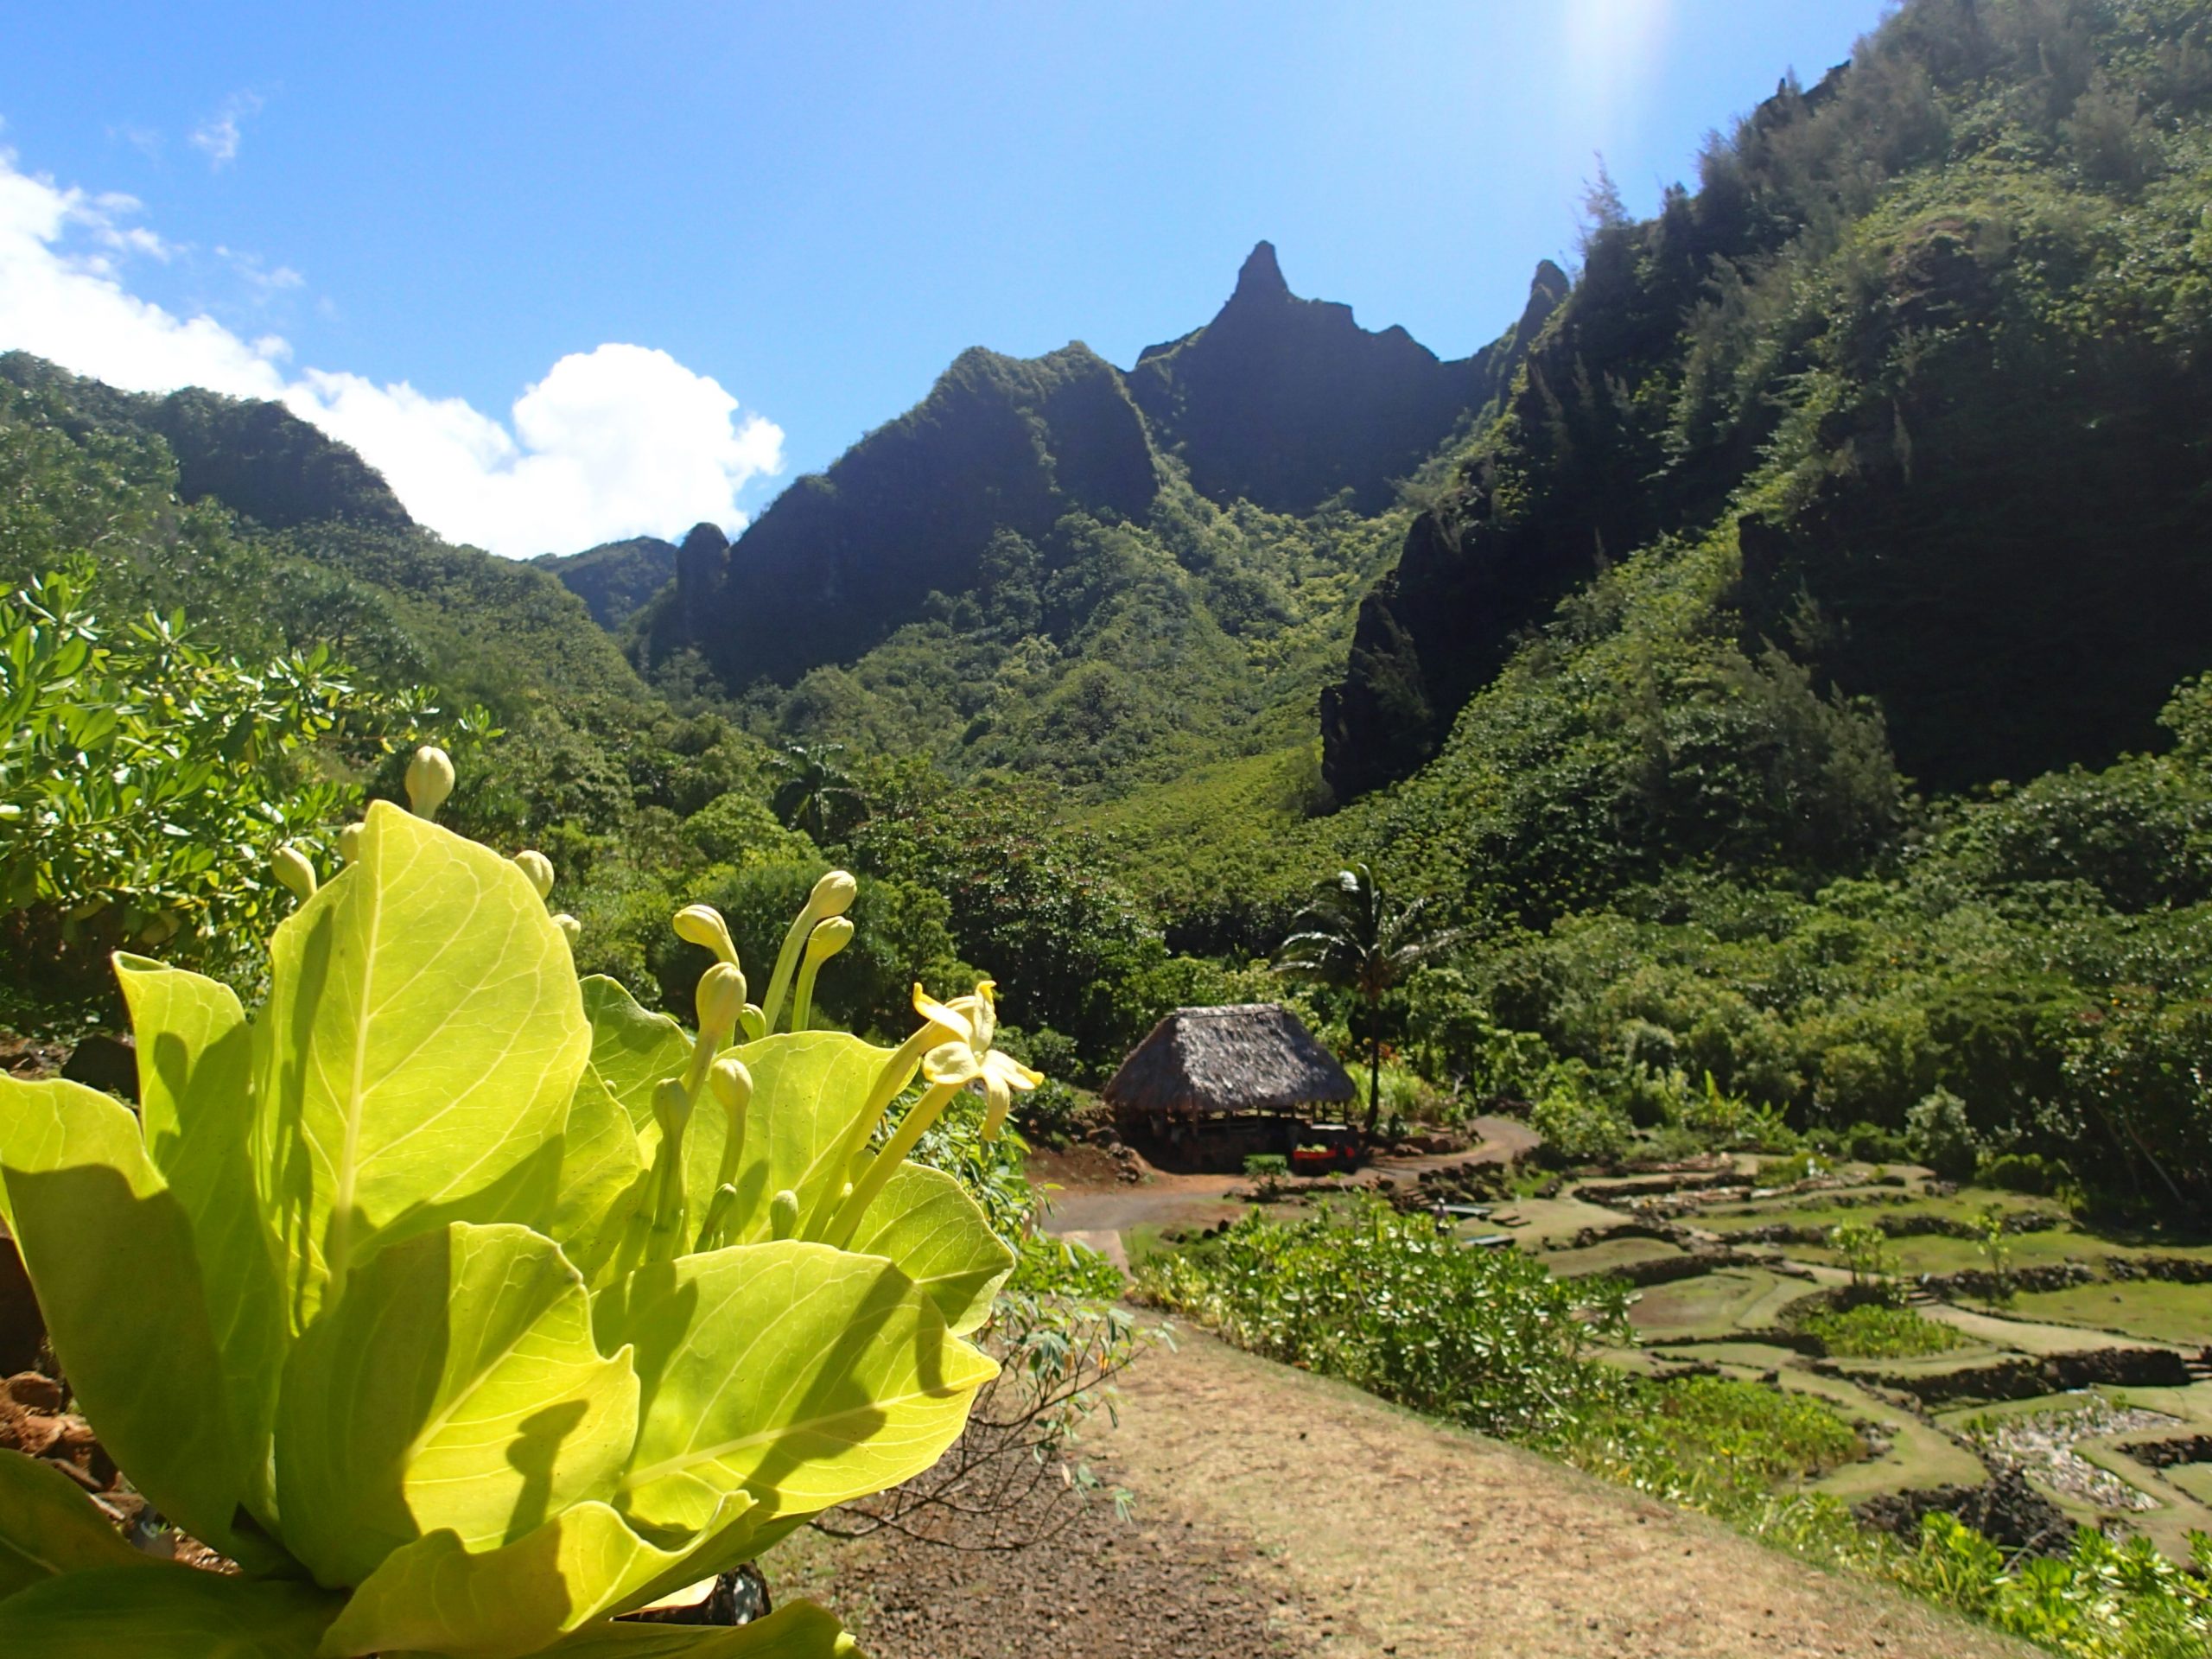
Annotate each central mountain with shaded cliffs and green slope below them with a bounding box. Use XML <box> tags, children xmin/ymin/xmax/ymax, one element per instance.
<box><xmin>644</xmin><ymin>244</ymin><xmax>1566</xmax><ymax>794</ymax></box>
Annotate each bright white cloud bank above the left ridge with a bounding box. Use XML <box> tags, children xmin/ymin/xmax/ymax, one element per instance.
<box><xmin>0</xmin><ymin>150</ymin><xmax>783</xmax><ymax>557</ymax></box>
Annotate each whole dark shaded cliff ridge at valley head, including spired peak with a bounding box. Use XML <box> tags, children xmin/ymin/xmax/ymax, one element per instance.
<box><xmin>645</xmin><ymin>244</ymin><xmax>1568</xmax><ymax>688</ymax></box>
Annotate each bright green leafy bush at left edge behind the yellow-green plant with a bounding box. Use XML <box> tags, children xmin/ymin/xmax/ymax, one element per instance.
<box><xmin>0</xmin><ymin>562</ymin><xmax>489</xmax><ymax>1031</ymax></box>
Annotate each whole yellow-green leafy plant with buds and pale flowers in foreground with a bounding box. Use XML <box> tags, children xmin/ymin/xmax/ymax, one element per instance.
<box><xmin>0</xmin><ymin>754</ymin><xmax>1017</xmax><ymax>1659</ymax></box>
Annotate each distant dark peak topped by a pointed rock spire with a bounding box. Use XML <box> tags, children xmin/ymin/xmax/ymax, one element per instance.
<box><xmin>1128</xmin><ymin>241</ymin><xmax>1566</xmax><ymax>513</ymax></box>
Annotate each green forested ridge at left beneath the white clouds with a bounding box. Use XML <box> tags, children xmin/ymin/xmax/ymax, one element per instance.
<box><xmin>0</xmin><ymin>352</ymin><xmax>690</xmax><ymax>836</ymax></box>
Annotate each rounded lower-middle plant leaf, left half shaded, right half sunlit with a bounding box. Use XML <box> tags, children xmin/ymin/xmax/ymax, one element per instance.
<box><xmin>276</xmin><ymin>1224</ymin><xmax>637</xmax><ymax>1586</ymax></box>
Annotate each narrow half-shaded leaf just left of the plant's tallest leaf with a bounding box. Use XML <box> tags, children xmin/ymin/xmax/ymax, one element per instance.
<box><xmin>115</xmin><ymin>956</ymin><xmax>289</xmax><ymax>1522</ymax></box>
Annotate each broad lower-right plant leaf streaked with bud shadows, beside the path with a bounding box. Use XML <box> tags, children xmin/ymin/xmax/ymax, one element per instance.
<box><xmin>597</xmin><ymin>1241</ymin><xmax>998</xmax><ymax>1531</ymax></box>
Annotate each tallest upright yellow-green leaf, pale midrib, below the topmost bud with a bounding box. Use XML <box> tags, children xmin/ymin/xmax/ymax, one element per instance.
<box><xmin>254</xmin><ymin>801</ymin><xmax>591</xmax><ymax>1330</ymax></box>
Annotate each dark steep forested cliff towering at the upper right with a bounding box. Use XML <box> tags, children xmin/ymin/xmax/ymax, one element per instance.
<box><xmin>1325</xmin><ymin>0</ymin><xmax>2212</xmax><ymax>794</ymax></box>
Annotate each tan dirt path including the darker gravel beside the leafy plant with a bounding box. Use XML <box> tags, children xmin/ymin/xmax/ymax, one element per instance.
<box><xmin>787</xmin><ymin>1334</ymin><xmax>2033</xmax><ymax>1659</ymax></box>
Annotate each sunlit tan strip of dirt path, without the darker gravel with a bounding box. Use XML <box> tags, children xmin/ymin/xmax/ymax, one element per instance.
<box><xmin>1113</xmin><ymin>1334</ymin><xmax>2024</xmax><ymax>1659</ymax></box>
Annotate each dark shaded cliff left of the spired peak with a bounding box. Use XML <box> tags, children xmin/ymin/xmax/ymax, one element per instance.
<box><xmin>651</xmin><ymin>343</ymin><xmax>1159</xmax><ymax>686</ymax></box>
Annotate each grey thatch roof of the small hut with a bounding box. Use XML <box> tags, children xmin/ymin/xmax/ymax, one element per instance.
<box><xmin>1106</xmin><ymin>1002</ymin><xmax>1358</xmax><ymax>1115</ymax></box>
